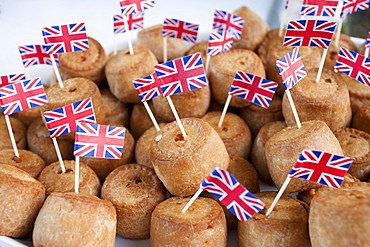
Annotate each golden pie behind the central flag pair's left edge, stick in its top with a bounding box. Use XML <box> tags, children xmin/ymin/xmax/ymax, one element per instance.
<box><xmin>105</xmin><ymin>45</ymin><xmax>158</xmax><ymax>103</ymax></box>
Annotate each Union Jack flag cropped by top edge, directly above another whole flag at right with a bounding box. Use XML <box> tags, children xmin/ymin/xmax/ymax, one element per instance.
<box><xmin>301</xmin><ymin>0</ymin><xmax>339</xmax><ymax>17</ymax></box>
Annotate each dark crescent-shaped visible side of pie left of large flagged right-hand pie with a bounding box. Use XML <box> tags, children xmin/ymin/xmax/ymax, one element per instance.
<box><xmin>251</xmin><ymin>121</ymin><xmax>287</xmax><ymax>184</ymax></box>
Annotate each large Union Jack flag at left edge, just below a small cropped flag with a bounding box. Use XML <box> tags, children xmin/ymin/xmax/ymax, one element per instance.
<box><xmin>0</xmin><ymin>77</ymin><xmax>48</xmax><ymax>115</ymax></box>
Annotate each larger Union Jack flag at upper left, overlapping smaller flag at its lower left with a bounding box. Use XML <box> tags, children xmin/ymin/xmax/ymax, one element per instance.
<box><xmin>42</xmin><ymin>23</ymin><xmax>89</xmax><ymax>54</ymax></box>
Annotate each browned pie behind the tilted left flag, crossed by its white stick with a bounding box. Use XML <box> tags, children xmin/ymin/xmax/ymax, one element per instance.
<box><xmin>27</xmin><ymin>117</ymin><xmax>74</xmax><ymax>165</ymax></box>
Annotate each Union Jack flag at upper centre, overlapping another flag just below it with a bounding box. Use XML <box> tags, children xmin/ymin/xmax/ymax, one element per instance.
<box><xmin>213</xmin><ymin>10</ymin><xmax>244</xmax><ymax>40</ymax></box>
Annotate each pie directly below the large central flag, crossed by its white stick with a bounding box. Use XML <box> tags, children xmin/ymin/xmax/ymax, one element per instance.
<box><xmin>153</xmin><ymin>87</ymin><xmax>211</xmax><ymax>122</ymax></box>
